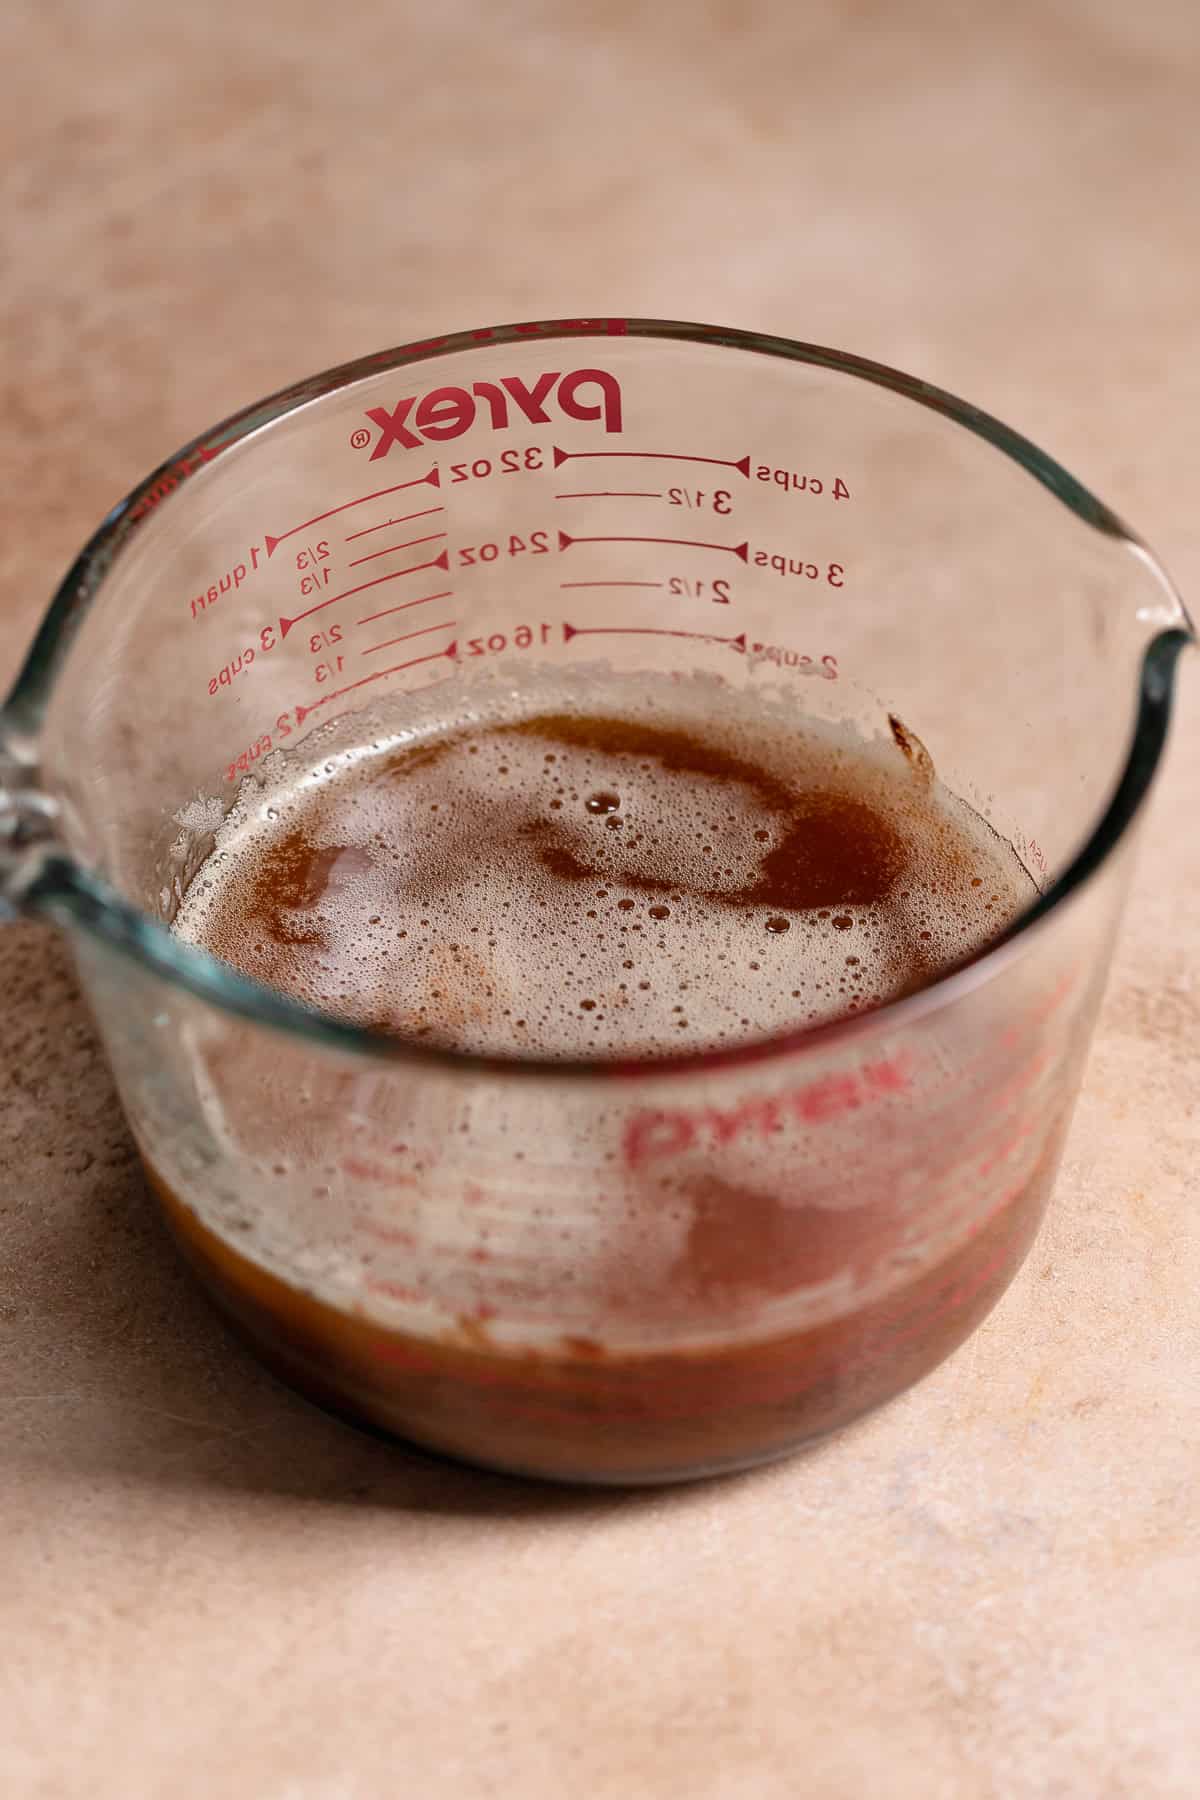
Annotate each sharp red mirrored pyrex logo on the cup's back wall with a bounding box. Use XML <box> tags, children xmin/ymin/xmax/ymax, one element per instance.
<box><xmin>367</xmin><ymin>369</ymin><xmax>621</xmax><ymax>463</ymax></box>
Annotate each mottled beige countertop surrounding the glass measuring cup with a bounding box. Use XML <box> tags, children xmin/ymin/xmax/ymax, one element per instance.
<box><xmin>0</xmin><ymin>0</ymin><xmax>1200</xmax><ymax>1800</ymax></box>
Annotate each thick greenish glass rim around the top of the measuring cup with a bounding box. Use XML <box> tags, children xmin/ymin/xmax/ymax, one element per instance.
<box><xmin>0</xmin><ymin>319</ymin><xmax>1196</xmax><ymax>1080</ymax></box>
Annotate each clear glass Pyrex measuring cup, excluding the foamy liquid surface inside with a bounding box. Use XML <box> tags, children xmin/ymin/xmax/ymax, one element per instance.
<box><xmin>0</xmin><ymin>320</ymin><xmax>1193</xmax><ymax>1481</ymax></box>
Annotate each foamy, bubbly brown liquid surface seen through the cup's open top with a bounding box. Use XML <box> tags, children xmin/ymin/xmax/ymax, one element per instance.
<box><xmin>175</xmin><ymin>675</ymin><xmax>1036</xmax><ymax>1058</ymax></box>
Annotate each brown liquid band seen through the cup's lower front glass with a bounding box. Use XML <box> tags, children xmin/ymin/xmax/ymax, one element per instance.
<box><xmin>149</xmin><ymin>1121</ymin><xmax>1065</xmax><ymax>1483</ymax></box>
